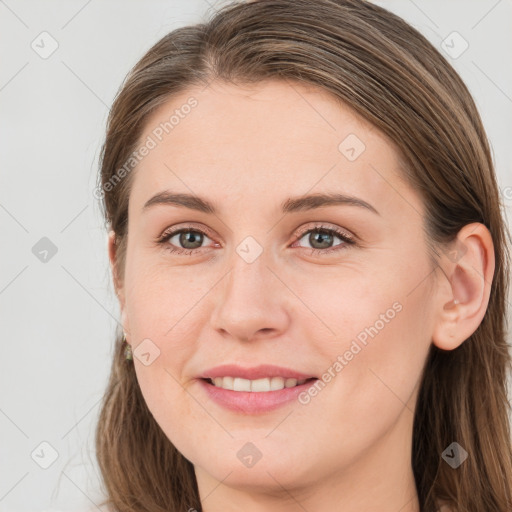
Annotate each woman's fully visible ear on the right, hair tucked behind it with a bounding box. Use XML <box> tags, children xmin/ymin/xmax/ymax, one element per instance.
<box><xmin>432</xmin><ymin>222</ymin><xmax>495</xmax><ymax>350</ymax></box>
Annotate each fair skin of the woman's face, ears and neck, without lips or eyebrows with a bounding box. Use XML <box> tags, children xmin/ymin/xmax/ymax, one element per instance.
<box><xmin>109</xmin><ymin>81</ymin><xmax>494</xmax><ymax>512</ymax></box>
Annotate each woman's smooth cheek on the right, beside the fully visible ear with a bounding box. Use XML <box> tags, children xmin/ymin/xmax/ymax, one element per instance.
<box><xmin>305</xmin><ymin>254</ymin><xmax>432</xmax><ymax>430</ymax></box>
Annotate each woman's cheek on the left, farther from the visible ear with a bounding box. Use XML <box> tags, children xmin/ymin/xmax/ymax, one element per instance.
<box><xmin>126</xmin><ymin>255</ymin><xmax>212</xmax><ymax>432</ymax></box>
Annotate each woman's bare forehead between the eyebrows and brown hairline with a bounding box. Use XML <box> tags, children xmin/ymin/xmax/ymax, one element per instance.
<box><xmin>130</xmin><ymin>81</ymin><xmax>420</xmax><ymax>217</ymax></box>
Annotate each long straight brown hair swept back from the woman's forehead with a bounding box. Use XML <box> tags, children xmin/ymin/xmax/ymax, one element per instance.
<box><xmin>96</xmin><ymin>0</ymin><xmax>512</xmax><ymax>512</ymax></box>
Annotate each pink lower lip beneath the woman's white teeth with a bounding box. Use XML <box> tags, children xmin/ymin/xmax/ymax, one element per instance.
<box><xmin>198</xmin><ymin>379</ymin><xmax>318</xmax><ymax>414</ymax></box>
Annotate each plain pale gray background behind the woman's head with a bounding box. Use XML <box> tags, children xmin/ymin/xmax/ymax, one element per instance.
<box><xmin>0</xmin><ymin>0</ymin><xmax>512</xmax><ymax>512</ymax></box>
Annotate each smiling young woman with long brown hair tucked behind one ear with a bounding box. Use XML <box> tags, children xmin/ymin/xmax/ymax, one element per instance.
<box><xmin>96</xmin><ymin>0</ymin><xmax>512</xmax><ymax>512</ymax></box>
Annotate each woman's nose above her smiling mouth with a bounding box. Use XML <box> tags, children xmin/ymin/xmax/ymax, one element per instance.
<box><xmin>207</xmin><ymin>255</ymin><xmax>291</xmax><ymax>341</ymax></box>
